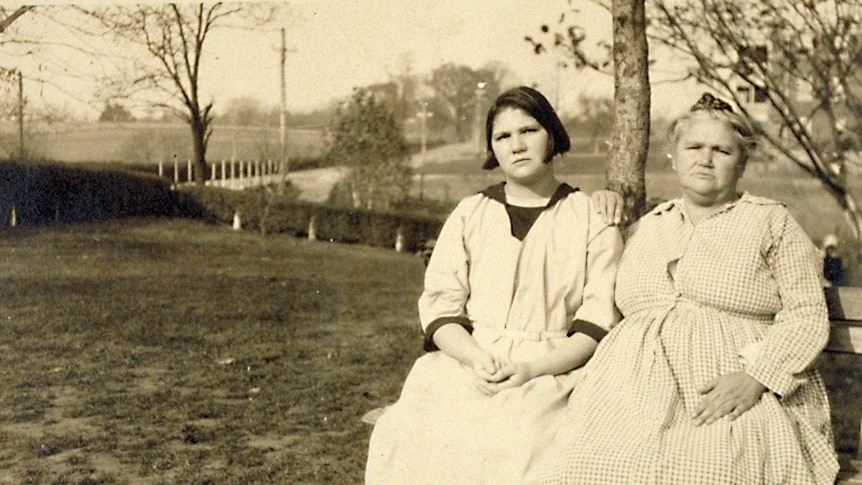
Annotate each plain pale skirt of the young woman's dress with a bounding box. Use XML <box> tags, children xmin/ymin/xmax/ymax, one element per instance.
<box><xmin>366</xmin><ymin>329</ymin><xmax>577</xmax><ymax>485</ymax></box>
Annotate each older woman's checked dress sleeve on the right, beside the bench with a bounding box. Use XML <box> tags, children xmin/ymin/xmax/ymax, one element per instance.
<box><xmin>746</xmin><ymin>207</ymin><xmax>829</xmax><ymax>397</ymax></box>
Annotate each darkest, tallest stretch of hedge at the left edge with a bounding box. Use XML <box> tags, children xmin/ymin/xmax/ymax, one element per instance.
<box><xmin>0</xmin><ymin>162</ymin><xmax>194</xmax><ymax>226</ymax></box>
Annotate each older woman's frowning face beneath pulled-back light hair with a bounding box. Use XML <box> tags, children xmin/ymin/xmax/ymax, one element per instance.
<box><xmin>673</xmin><ymin>118</ymin><xmax>743</xmax><ymax>205</ymax></box>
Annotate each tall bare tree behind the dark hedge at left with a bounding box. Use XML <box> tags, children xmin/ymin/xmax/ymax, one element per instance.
<box><xmin>86</xmin><ymin>2</ymin><xmax>262</xmax><ymax>185</ymax></box>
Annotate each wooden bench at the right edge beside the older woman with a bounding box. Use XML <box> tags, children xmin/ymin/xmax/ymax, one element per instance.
<box><xmin>822</xmin><ymin>287</ymin><xmax>862</xmax><ymax>485</ymax></box>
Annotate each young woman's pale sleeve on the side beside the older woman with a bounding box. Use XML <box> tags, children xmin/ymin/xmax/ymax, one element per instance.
<box><xmin>575</xmin><ymin>211</ymin><xmax>623</xmax><ymax>332</ymax></box>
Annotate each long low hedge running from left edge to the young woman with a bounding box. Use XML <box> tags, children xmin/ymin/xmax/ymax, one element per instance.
<box><xmin>0</xmin><ymin>162</ymin><xmax>442</xmax><ymax>251</ymax></box>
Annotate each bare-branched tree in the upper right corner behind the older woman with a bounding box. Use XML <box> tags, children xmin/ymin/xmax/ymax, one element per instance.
<box><xmin>650</xmin><ymin>0</ymin><xmax>862</xmax><ymax>239</ymax></box>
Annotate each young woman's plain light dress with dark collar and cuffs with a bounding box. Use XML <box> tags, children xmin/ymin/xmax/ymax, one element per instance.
<box><xmin>366</xmin><ymin>185</ymin><xmax>622</xmax><ymax>484</ymax></box>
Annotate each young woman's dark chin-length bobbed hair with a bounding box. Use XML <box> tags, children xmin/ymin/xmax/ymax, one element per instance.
<box><xmin>482</xmin><ymin>86</ymin><xmax>572</xmax><ymax>170</ymax></box>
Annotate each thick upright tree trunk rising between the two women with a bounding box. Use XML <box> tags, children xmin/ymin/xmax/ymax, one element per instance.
<box><xmin>607</xmin><ymin>0</ymin><xmax>650</xmax><ymax>224</ymax></box>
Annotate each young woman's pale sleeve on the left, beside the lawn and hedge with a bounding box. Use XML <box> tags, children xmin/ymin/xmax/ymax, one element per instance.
<box><xmin>419</xmin><ymin>202</ymin><xmax>472</xmax><ymax>351</ymax></box>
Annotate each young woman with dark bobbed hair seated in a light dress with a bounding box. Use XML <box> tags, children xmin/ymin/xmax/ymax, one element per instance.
<box><xmin>366</xmin><ymin>87</ymin><xmax>622</xmax><ymax>484</ymax></box>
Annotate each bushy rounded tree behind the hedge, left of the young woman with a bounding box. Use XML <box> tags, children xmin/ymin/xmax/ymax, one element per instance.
<box><xmin>326</xmin><ymin>89</ymin><xmax>411</xmax><ymax>210</ymax></box>
